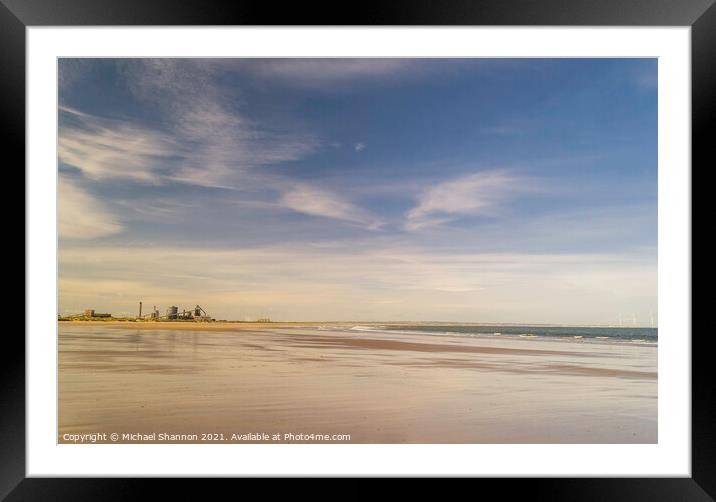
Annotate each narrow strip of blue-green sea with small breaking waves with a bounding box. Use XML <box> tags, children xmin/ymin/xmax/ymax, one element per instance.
<box><xmin>344</xmin><ymin>323</ymin><xmax>659</xmax><ymax>345</ymax></box>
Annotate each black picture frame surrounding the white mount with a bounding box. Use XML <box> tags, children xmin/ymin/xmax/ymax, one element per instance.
<box><xmin>0</xmin><ymin>0</ymin><xmax>716</xmax><ymax>501</ymax></box>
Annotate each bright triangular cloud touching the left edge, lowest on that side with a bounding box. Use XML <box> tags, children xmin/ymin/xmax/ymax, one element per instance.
<box><xmin>57</xmin><ymin>176</ymin><xmax>123</xmax><ymax>239</ymax></box>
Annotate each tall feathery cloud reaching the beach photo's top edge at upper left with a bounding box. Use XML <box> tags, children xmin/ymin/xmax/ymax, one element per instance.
<box><xmin>126</xmin><ymin>59</ymin><xmax>319</xmax><ymax>187</ymax></box>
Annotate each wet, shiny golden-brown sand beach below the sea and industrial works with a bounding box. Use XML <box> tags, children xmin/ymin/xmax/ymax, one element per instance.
<box><xmin>58</xmin><ymin>322</ymin><xmax>657</xmax><ymax>443</ymax></box>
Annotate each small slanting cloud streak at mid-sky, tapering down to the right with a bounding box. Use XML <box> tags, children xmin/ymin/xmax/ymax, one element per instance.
<box><xmin>279</xmin><ymin>184</ymin><xmax>382</xmax><ymax>229</ymax></box>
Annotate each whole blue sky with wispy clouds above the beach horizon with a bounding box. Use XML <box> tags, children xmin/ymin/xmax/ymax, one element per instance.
<box><xmin>58</xmin><ymin>59</ymin><xmax>657</xmax><ymax>326</ymax></box>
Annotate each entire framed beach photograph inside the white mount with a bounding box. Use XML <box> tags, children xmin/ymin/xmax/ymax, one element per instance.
<box><xmin>58</xmin><ymin>57</ymin><xmax>656</xmax><ymax>445</ymax></box>
